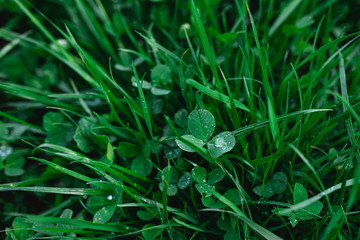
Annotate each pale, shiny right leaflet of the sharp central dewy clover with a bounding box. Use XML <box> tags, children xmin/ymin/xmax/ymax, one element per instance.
<box><xmin>208</xmin><ymin>132</ymin><xmax>236</xmax><ymax>158</ymax></box>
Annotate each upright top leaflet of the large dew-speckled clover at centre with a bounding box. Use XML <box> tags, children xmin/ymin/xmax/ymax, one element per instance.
<box><xmin>188</xmin><ymin>109</ymin><xmax>215</xmax><ymax>141</ymax></box>
